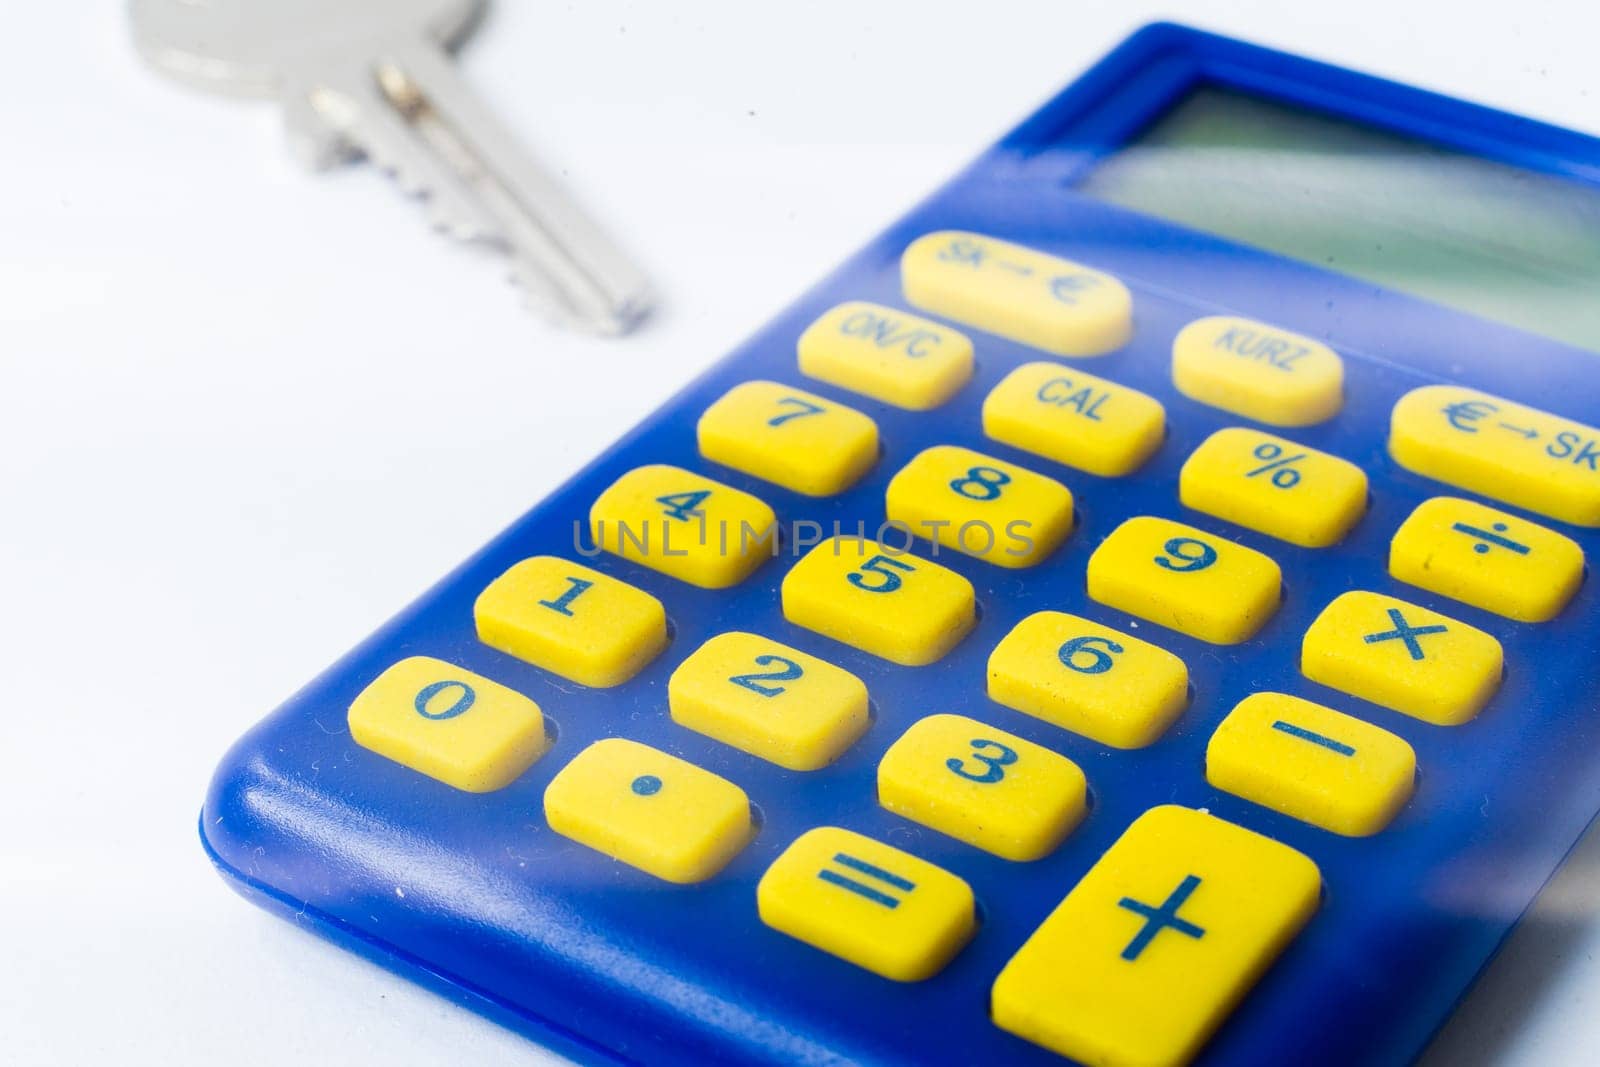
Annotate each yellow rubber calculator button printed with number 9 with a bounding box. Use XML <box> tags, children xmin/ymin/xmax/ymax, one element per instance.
<box><xmin>1088</xmin><ymin>515</ymin><xmax>1283</xmax><ymax>645</ymax></box>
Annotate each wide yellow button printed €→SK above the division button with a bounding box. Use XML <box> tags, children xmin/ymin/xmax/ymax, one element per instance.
<box><xmin>1389</xmin><ymin>386</ymin><xmax>1600</xmax><ymax>526</ymax></box>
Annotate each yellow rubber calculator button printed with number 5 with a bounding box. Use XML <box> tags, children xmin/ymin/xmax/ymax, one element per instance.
<box><xmin>782</xmin><ymin>537</ymin><xmax>978</xmax><ymax>667</ymax></box>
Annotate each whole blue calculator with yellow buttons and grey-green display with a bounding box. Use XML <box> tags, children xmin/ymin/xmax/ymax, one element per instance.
<box><xmin>200</xmin><ymin>24</ymin><xmax>1600</xmax><ymax>1067</ymax></box>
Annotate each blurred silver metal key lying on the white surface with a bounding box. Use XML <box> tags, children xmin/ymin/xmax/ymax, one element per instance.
<box><xmin>130</xmin><ymin>0</ymin><xmax>651</xmax><ymax>334</ymax></box>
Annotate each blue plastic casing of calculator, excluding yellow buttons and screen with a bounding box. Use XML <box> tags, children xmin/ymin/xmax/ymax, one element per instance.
<box><xmin>202</xmin><ymin>26</ymin><xmax>1600</xmax><ymax>1064</ymax></box>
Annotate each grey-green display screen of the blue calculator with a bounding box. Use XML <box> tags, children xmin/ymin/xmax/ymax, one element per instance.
<box><xmin>1082</xmin><ymin>86</ymin><xmax>1600</xmax><ymax>352</ymax></box>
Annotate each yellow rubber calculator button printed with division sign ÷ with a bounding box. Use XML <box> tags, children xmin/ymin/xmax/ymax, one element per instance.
<box><xmin>1389</xmin><ymin>496</ymin><xmax>1584</xmax><ymax>622</ymax></box>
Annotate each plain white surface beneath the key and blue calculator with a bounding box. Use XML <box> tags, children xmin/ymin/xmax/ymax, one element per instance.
<box><xmin>0</xmin><ymin>0</ymin><xmax>1600</xmax><ymax>1067</ymax></box>
